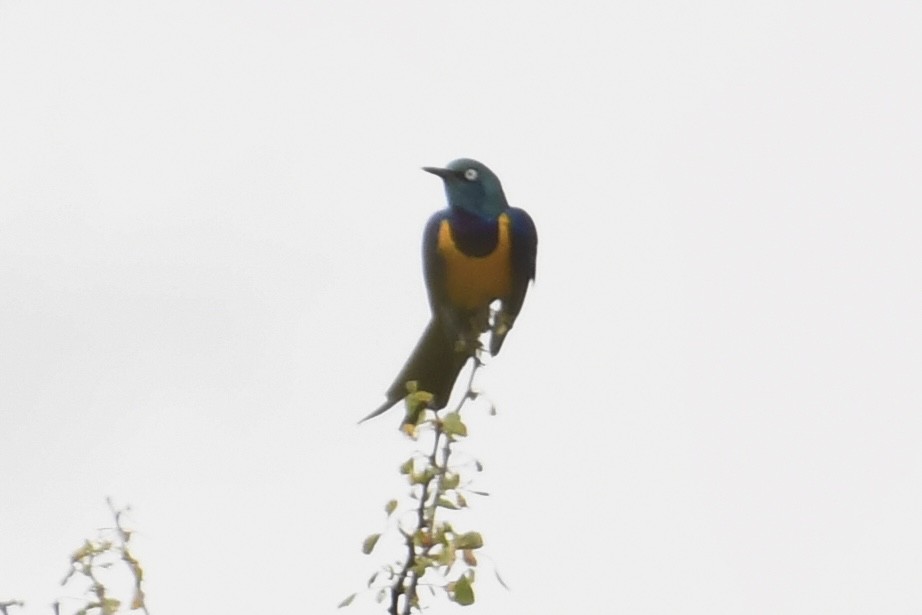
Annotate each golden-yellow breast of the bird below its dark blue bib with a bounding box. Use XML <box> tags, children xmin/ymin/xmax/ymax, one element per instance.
<box><xmin>438</xmin><ymin>214</ymin><xmax>512</xmax><ymax>310</ymax></box>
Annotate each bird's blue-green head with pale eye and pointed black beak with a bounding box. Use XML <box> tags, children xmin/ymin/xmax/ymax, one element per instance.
<box><xmin>423</xmin><ymin>158</ymin><xmax>509</xmax><ymax>218</ymax></box>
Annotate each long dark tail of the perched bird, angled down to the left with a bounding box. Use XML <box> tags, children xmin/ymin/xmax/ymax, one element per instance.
<box><xmin>359</xmin><ymin>317</ymin><xmax>470</xmax><ymax>423</ymax></box>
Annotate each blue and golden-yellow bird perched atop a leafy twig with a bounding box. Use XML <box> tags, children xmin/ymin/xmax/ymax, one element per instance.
<box><xmin>359</xmin><ymin>158</ymin><xmax>538</xmax><ymax>423</ymax></box>
